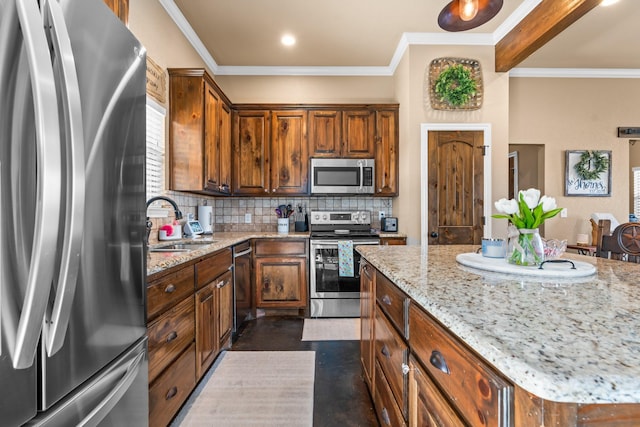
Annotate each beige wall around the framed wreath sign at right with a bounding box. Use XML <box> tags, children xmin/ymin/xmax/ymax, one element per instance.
<box><xmin>509</xmin><ymin>78</ymin><xmax>640</xmax><ymax>242</ymax></box>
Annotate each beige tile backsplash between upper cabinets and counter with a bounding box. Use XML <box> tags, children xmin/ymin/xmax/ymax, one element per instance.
<box><xmin>150</xmin><ymin>191</ymin><xmax>393</xmax><ymax>243</ymax></box>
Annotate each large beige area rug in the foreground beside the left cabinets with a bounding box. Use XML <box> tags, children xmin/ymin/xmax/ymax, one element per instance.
<box><xmin>179</xmin><ymin>351</ymin><xmax>315</xmax><ymax>427</ymax></box>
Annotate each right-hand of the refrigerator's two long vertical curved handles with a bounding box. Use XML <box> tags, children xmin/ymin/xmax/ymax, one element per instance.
<box><xmin>43</xmin><ymin>0</ymin><xmax>86</xmax><ymax>357</ymax></box>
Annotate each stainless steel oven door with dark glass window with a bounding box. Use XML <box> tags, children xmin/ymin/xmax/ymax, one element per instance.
<box><xmin>310</xmin><ymin>239</ymin><xmax>380</xmax><ymax>298</ymax></box>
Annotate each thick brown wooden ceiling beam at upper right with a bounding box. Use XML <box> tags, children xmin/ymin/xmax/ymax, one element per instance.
<box><xmin>495</xmin><ymin>0</ymin><xmax>602</xmax><ymax>72</ymax></box>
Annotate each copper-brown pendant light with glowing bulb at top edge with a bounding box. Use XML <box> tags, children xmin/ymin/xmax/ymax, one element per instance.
<box><xmin>438</xmin><ymin>0</ymin><xmax>503</xmax><ymax>31</ymax></box>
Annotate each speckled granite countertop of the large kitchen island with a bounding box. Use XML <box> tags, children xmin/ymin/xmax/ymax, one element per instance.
<box><xmin>357</xmin><ymin>245</ymin><xmax>640</xmax><ymax>404</ymax></box>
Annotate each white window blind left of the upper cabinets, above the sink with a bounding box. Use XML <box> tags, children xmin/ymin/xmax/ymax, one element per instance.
<box><xmin>147</xmin><ymin>97</ymin><xmax>166</xmax><ymax>200</ymax></box>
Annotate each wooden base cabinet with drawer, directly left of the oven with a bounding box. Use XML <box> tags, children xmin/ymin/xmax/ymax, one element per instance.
<box><xmin>254</xmin><ymin>239</ymin><xmax>308</xmax><ymax>308</ymax></box>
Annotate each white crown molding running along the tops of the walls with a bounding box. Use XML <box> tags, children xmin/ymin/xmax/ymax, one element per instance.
<box><xmin>158</xmin><ymin>0</ymin><xmax>640</xmax><ymax>78</ymax></box>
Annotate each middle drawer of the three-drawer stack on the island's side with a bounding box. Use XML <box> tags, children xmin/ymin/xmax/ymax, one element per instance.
<box><xmin>374</xmin><ymin>310</ymin><xmax>409</xmax><ymax>414</ymax></box>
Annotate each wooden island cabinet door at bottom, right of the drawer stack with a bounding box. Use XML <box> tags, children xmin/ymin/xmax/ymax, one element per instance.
<box><xmin>409</xmin><ymin>356</ymin><xmax>465</xmax><ymax>427</ymax></box>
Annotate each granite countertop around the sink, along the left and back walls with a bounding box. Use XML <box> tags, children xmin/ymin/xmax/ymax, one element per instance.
<box><xmin>147</xmin><ymin>231</ymin><xmax>309</xmax><ymax>277</ymax></box>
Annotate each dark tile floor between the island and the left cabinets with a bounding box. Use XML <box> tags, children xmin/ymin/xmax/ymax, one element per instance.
<box><xmin>230</xmin><ymin>317</ymin><xmax>378</xmax><ymax>427</ymax></box>
